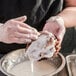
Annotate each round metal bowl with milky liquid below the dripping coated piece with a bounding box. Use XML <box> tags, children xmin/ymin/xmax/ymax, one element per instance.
<box><xmin>0</xmin><ymin>49</ymin><xmax>65</xmax><ymax>76</ymax></box>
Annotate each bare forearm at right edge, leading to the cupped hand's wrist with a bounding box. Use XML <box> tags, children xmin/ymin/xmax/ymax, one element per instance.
<box><xmin>58</xmin><ymin>7</ymin><xmax>76</xmax><ymax>27</ymax></box>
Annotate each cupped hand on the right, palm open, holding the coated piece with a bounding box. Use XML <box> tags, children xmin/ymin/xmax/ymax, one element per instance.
<box><xmin>43</xmin><ymin>16</ymin><xmax>65</xmax><ymax>52</ymax></box>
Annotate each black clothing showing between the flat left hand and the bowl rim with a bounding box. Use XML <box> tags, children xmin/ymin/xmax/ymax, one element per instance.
<box><xmin>0</xmin><ymin>42</ymin><xmax>26</xmax><ymax>54</ymax></box>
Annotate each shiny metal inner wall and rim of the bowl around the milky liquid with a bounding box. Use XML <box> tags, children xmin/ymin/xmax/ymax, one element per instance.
<box><xmin>0</xmin><ymin>49</ymin><xmax>65</xmax><ymax>76</ymax></box>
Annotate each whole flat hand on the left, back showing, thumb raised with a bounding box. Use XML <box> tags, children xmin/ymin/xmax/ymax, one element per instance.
<box><xmin>0</xmin><ymin>16</ymin><xmax>39</xmax><ymax>44</ymax></box>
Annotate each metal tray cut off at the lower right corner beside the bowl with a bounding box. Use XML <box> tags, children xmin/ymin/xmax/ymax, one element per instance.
<box><xmin>66</xmin><ymin>54</ymin><xmax>76</xmax><ymax>76</ymax></box>
